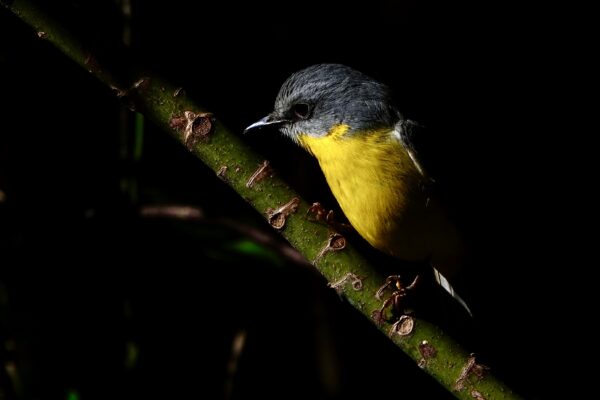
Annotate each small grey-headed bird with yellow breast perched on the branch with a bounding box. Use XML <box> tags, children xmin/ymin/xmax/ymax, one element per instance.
<box><xmin>244</xmin><ymin>64</ymin><xmax>471</xmax><ymax>314</ymax></box>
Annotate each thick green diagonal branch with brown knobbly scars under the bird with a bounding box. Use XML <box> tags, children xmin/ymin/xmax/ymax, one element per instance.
<box><xmin>0</xmin><ymin>0</ymin><xmax>518</xmax><ymax>399</ymax></box>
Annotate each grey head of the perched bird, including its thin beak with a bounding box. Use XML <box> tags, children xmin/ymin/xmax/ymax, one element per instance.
<box><xmin>241</xmin><ymin>64</ymin><xmax>402</xmax><ymax>141</ymax></box>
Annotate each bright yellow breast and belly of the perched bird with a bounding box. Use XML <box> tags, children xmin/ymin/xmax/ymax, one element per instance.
<box><xmin>299</xmin><ymin>125</ymin><xmax>429</xmax><ymax>259</ymax></box>
